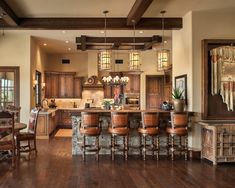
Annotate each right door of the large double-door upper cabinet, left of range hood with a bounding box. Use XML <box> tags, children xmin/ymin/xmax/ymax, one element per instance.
<box><xmin>59</xmin><ymin>74</ymin><xmax>74</xmax><ymax>98</ymax></box>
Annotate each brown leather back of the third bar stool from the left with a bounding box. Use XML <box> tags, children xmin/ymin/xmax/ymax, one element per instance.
<box><xmin>141</xmin><ymin>112</ymin><xmax>159</xmax><ymax>128</ymax></box>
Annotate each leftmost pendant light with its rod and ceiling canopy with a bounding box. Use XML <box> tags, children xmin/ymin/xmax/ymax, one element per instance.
<box><xmin>98</xmin><ymin>10</ymin><xmax>112</xmax><ymax>71</ymax></box>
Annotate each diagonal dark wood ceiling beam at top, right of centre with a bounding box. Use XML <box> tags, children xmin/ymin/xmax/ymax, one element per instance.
<box><xmin>126</xmin><ymin>0</ymin><xmax>153</xmax><ymax>26</ymax></box>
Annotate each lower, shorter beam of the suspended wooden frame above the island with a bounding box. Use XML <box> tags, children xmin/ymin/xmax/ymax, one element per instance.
<box><xmin>77</xmin><ymin>44</ymin><xmax>144</xmax><ymax>50</ymax></box>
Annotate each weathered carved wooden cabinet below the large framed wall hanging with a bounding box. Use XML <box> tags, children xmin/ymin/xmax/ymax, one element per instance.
<box><xmin>200</xmin><ymin>122</ymin><xmax>235</xmax><ymax>165</ymax></box>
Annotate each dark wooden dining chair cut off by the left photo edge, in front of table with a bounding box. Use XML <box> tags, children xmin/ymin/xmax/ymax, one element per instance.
<box><xmin>0</xmin><ymin>111</ymin><xmax>16</xmax><ymax>168</ymax></box>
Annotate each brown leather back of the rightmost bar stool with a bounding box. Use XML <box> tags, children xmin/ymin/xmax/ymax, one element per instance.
<box><xmin>171</xmin><ymin>112</ymin><xmax>188</xmax><ymax>128</ymax></box>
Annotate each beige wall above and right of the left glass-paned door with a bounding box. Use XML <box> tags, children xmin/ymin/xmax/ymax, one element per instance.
<box><xmin>0</xmin><ymin>31</ymin><xmax>31</xmax><ymax>123</ymax></box>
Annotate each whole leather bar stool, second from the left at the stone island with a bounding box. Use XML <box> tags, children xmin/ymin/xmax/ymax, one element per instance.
<box><xmin>108</xmin><ymin>112</ymin><xmax>130</xmax><ymax>160</ymax></box>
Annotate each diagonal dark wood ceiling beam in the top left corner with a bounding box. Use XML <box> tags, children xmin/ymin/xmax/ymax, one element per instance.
<box><xmin>0</xmin><ymin>0</ymin><xmax>20</xmax><ymax>26</ymax></box>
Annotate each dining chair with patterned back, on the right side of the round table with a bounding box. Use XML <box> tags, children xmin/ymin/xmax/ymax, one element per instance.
<box><xmin>16</xmin><ymin>108</ymin><xmax>40</xmax><ymax>159</ymax></box>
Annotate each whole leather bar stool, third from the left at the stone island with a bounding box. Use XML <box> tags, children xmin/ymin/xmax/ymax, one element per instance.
<box><xmin>138</xmin><ymin>112</ymin><xmax>159</xmax><ymax>160</ymax></box>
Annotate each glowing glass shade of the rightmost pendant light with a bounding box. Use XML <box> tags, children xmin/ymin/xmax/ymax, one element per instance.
<box><xmin>157</xmin><ymin>49</ymin><xmax>171</xmax><ymax>71</ymax></box>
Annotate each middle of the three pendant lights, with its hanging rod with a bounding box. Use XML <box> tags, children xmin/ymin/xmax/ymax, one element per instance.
<box><xmin>129</xmin><ymin>20</ymin><xmax>140</xmax><ymax>71</ymax></box>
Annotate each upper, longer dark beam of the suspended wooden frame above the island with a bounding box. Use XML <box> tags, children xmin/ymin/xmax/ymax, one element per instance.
<box><xmin>76</xmin><ymin>35</ymin><xmax>162</xmax><ymax>43</ymax></box>
